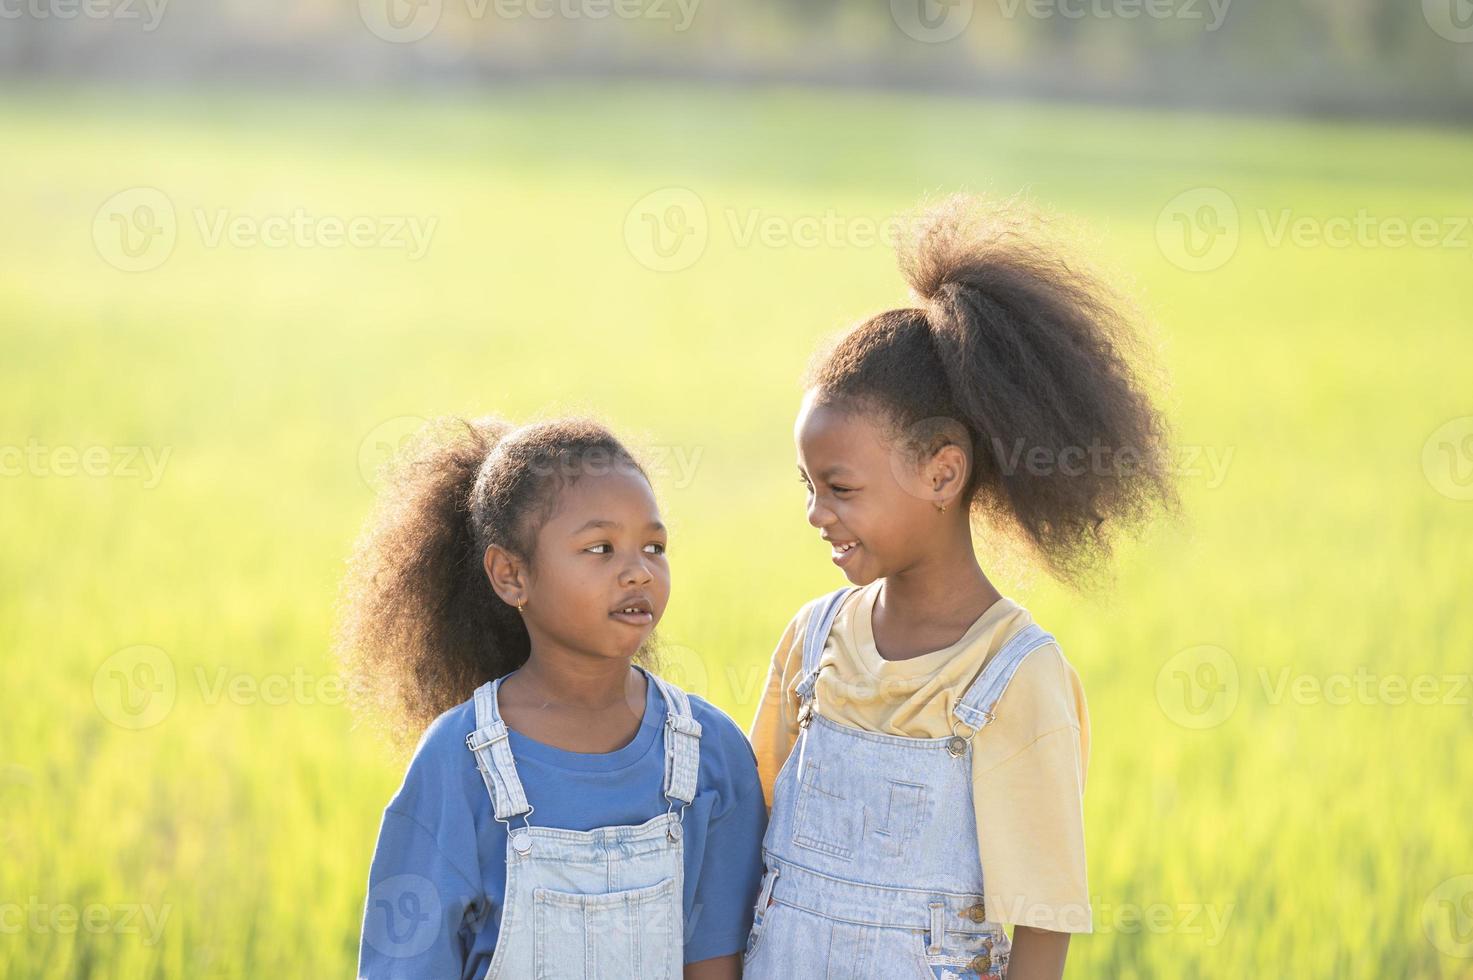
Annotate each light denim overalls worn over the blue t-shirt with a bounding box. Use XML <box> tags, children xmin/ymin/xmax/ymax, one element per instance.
<box><xmin>465</xmin><ymin>671</ymin><xmax>701</xmax><ymax>980</ymax></box>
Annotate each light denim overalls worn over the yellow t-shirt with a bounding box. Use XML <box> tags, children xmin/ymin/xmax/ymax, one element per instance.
<box><xmin>744</xmin><ymin>588</ymin><xmax>1053</xmax><ymax>980</ymax></box>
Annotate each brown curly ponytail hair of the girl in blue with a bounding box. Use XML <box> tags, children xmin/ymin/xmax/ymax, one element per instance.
<box><xmin>336</xmin><ymin>417</ymin><xmax>648</xmax><ymax>744</ymax></box>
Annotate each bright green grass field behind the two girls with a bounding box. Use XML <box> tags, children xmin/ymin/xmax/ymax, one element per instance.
<box><xmin>0</xmin><ymin>87</ymin><xmax>1473</xmax><ymax>979</ymax></box>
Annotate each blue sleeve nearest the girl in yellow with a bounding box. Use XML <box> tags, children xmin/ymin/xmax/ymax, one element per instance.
<box><xmin>685</xmin><ymin>709</ymin><xmax>767</xmax><ymax>962</ymax></box>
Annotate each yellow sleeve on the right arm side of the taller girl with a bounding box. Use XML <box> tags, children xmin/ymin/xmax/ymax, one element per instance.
<box><xmin>972</xmin><ymin>644</ymin><xmax>1093</xmax><ymax>933</ymax></box>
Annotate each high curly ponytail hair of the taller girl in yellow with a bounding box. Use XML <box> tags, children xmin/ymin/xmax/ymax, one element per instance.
<box><xmin>807</xmin><ymin>196</ymin><xmax>1177</xmax><ymax>587</ymax></box>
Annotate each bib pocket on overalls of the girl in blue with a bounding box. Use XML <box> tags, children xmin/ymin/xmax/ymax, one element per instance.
<box><xmin>532</xmin><ymin>878</ymin><xmax>683</xmax><ymax>980</ymax></box>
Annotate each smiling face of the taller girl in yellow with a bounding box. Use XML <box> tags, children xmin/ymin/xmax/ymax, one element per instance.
<box><xmin>794</xmin><ymin>391</ymin><xmax>965</xmax><ymax>585</ymax></box>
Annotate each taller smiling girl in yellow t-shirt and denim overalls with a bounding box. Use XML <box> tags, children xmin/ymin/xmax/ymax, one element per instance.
<box><xmin>745</xmin><ymin>199</ymin><xmax>1175</xmax><ymax>980</ymax></box>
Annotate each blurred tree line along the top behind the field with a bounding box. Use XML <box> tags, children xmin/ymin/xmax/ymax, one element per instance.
<box><xmin>0</xmin><ymin>0</ymin><xmax>1473</xmax><ymax>119</ymax></box>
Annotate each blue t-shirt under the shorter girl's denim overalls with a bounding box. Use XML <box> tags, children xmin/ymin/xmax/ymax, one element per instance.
<box><xmin>358</xmin><ymin>666</ymin><xmax>767</xmax><ymax>980</ymax></box>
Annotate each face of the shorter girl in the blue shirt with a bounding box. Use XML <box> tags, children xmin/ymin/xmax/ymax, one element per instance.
<box><xmin>509</xmin><ymin>466</ymin><xmax>670</xmax><ymax>659</ymax></box>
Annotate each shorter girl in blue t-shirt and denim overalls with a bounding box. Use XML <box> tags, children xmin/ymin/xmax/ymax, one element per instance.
<box><xmin>340</xmin><ymin>420</ymin><xmax>766</xmax><ymax>980</ymax></box>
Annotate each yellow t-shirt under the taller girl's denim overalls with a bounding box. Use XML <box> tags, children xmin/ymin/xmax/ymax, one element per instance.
<box><xmin>751</xmin><ymin>579</ymin><xmax>1093</xmax><ymax>933</ymax></box>
